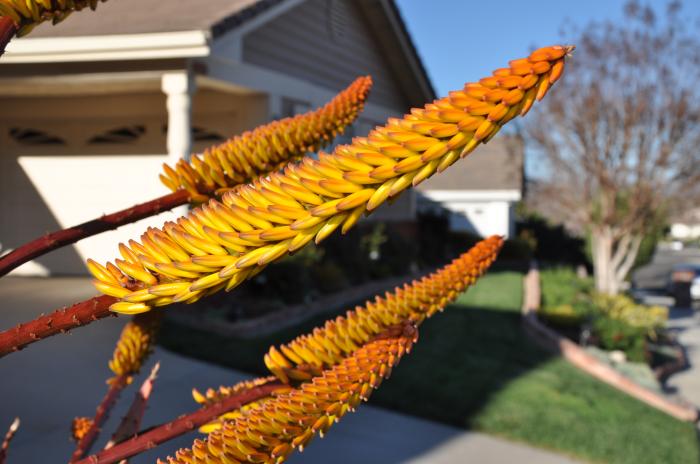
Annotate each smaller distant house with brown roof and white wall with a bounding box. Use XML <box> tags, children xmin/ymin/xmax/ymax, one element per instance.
<box><xmin>418</xmin><ymin>135</ymin><xmax>524</xmax><ymax>237</ymax></box>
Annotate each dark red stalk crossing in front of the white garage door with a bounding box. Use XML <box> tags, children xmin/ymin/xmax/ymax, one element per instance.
<box><xmin>0</xmin><ymin>190</ymin><xmax>190</xmax><ymax>277</ymax></box>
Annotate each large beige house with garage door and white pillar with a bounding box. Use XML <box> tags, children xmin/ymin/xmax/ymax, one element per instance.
<box><xmin>0</xmin><ymin>0</ymin><xmax>435</xmax><ymax>275</ymax></box>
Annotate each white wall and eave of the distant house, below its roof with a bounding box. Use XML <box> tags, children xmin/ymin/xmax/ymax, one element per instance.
<box><xmin>418</xmin><ymin>190</ymin><xmax>521</xmax><ymax>237</ymax></box>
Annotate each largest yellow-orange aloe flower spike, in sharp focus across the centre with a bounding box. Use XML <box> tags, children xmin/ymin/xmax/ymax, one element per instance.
<box><xmin>88</xmin><ymin>46</ymin><xmax>573</xmax><ymax>314</ymax></box>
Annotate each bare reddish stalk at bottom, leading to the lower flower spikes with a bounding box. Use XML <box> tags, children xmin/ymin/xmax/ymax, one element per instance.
<box><xmin>76</xmin><ymin>382</ymin><xmax>283</xmax><ymax>464</ymax></box>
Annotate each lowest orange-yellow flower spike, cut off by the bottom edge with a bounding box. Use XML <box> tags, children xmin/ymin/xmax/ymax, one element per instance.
<box><xmin>159</xmin><ymin>324</ymin><xmax>418</xmax><ymax>464</ymax></box>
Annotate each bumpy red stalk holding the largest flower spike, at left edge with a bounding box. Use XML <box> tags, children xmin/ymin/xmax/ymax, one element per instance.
<box><xmin>0</xmin><ymin>295</ymin><xmax>118</xmax><ymax>357</ymax></box>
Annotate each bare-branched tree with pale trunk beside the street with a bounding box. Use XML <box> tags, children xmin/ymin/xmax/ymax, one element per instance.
<box><xmin>525</xmin><ymin>1</ymin><xmax>700</xmax><ymax>294</ymax></box>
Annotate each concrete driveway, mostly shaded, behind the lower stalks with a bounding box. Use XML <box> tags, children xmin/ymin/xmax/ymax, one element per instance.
<box><xmin>0</xmin><ymin>277</ymin><xmax>574</xmax><ymax>464</ymax></box>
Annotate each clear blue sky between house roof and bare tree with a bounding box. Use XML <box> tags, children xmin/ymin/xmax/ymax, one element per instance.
<box><xmin>396</xmin><ymin>0</ymin><xmax>700</xmax><ymax>96</ymax></box>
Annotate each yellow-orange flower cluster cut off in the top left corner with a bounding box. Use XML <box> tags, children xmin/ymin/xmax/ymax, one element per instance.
<box><xmin>0</xmin><ymin>0</ymin><xmax>107</xmax><ymax>37</ymax></box>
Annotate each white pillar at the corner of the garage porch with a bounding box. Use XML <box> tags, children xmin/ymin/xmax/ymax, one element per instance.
<box><xmin>161</xmin><ymin>71</ymin><xmax>195</xmax><ymax>165</ymax></box>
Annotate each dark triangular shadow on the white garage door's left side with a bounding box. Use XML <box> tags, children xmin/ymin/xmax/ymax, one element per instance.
<box><xmin>0</xmin><ymin>153</ymin><xmax>85</xmax><ymax>275</ymax></box>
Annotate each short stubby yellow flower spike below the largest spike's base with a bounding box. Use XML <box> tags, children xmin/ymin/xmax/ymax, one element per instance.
<box><xmin>108</xmin><ymin>311</ymin><xmax>163</xmax><ymax>382</ymax></box>
